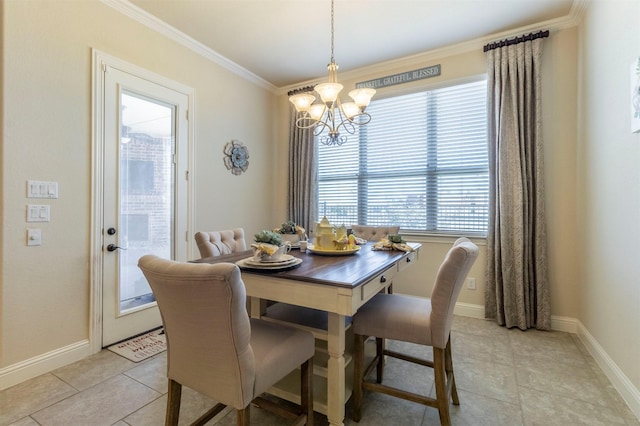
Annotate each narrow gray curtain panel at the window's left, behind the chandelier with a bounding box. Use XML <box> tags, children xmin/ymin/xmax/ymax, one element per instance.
<box><xmin>288</xmin><ymin>105</ymin><xmax>318</xmax><ymax>235</ymax></box>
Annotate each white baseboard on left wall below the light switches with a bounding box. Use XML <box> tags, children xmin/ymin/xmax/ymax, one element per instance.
<box><xmin>0</xmin><ymin>340</ymin><xmax>91</xmax><ymax>390</ymax></box>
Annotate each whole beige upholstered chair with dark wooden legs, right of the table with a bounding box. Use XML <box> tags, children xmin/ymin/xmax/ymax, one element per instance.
<box><xmin>353</xmin><ymin>238</ymin><xmax>478</xmax><ymax>425</ymax></box>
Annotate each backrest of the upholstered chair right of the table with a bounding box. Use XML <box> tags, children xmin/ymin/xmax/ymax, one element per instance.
<box><xmin>430</xmin><ymin>238</ymin><xmax>478</xmax><ymax>348</ymax></box>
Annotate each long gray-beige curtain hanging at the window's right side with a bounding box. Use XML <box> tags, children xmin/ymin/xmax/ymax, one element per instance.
<box><xmin>485</xmin><ymin>38</ymin><xmax>551</xmax><ymax>330</ymax></box>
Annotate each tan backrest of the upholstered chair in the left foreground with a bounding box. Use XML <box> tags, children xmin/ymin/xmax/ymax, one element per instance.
<box><xmin>138</xmin><ymin>255</ymin><xmax>255</xmax><ymax>407</ymax></box>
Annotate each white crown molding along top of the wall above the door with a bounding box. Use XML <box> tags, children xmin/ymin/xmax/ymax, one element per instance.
<box><xmin>100</xmin><ymin>0</ymin><xmax>278</xmax><ymax>93</ymax></box>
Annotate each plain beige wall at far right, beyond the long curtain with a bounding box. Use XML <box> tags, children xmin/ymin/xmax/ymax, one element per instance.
<box><xmin>576</xmin><ymin>0</ymin><xmax>640</xmax><ymax>394</ymax></box>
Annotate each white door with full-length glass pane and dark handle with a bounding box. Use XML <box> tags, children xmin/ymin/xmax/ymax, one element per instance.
<box><xmin>101</xmin><ymin>60</ymin><xmax>189</xmax><ymax>347</ymax></box>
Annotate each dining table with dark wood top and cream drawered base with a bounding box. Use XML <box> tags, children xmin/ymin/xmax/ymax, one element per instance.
<box><xmin>192</xmin><ymin>242</ymin><xmax>421</xmax><ymax>426</ymax></box>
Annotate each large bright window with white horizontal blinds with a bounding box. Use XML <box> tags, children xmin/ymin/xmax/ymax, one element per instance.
<box><xmin>317</xmin><ymin>80</ymin><xmax>489</xmax><ymax>235</ymax></box>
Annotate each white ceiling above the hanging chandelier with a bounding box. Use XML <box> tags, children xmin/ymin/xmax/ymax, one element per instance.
<box><xmin>125</xmin><ymin>0</ymin><xmax>583</xmax><ymax>88</ymax></box>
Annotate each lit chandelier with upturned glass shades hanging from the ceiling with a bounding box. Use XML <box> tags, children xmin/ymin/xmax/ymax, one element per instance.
<box><xmin>289</xmin><ymin>0</ymin><xmax>376</xmax><ymax>145</ymax></box>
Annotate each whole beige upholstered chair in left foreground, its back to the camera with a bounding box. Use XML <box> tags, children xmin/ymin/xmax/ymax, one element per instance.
<box><xmin>138</xmin><ymin>255</ymin><xmax>315</xmax><ymax>426</ymax></box>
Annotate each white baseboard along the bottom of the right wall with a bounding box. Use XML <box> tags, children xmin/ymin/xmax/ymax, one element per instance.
<box><xmin>577</xmin><ymin>321</ymin><xmax>640</xmax><ymax>419</ymax></box>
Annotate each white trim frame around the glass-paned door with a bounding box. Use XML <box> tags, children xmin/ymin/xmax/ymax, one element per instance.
<box><xmin>89</xmin><ymin>49</ymin><xmax>195</xmax><ymax>354</ymax></box>
